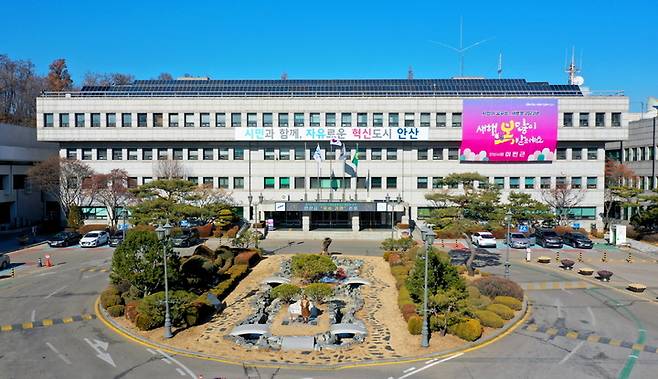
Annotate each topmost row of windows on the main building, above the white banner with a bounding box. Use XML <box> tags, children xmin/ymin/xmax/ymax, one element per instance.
<box><xmin>43</xmin><ymin>112</ymin><xmax>621</xmax><ymax>128</ymax></box>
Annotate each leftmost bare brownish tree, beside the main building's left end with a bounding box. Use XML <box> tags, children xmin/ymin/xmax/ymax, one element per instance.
<box><xmin>28</xmin><ymin>156</ymin><xmax>93</xmax><ymax>216</ymax></box>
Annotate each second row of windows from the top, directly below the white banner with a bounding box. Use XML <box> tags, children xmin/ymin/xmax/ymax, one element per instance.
<box><xmin>66</xmin><ymin>147</ymin><xmax>598</xmax><ymax>161</ymax></box>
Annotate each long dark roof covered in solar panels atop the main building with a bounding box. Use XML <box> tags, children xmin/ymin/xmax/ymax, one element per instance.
<box><xmin>44</xmin><ymin>78</ymin><xmax>583</xmax><ymax>97</ymax></box>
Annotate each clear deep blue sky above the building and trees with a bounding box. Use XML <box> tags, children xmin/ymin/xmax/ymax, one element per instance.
<box><xmin>0</xmin><ymin>0</ymin><xmax>658</xmax><ymax>111</ymax></box>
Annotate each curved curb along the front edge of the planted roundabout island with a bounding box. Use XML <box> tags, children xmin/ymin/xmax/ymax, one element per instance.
<box><xmin>94</xmin><ymin>296</ymin><xmax>531</xmax><ymax>371</ymax></box>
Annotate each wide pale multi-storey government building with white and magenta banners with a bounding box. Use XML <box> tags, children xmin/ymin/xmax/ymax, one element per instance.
<box><xmin>37</xmin><ymin>78</ymin><xmax>629</xmax><ymax>231</ymax></box>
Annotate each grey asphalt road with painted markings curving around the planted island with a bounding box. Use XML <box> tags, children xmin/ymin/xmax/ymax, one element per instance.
<box><xmin>0</xmin><ymin>241</ymin><xmax>658</xmax><ymax>379</ymax></box>
